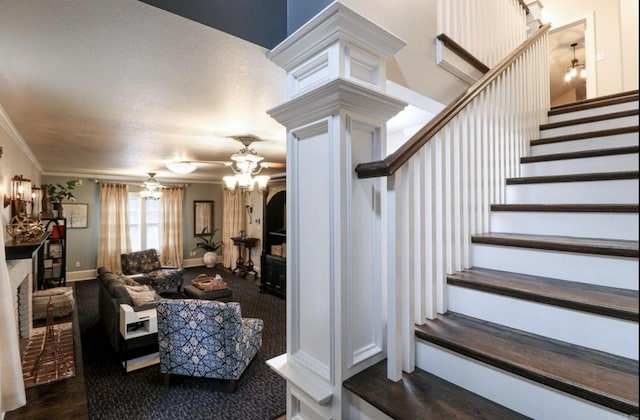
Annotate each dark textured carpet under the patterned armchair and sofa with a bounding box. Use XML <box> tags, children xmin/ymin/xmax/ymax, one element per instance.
<box><xmin>74</xmin><ymin>267</ymin><xmax>286</xmax><ymax>420</ymax></box>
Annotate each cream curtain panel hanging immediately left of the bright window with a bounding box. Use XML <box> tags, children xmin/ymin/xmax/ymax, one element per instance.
<box><xmin>98</xmin><ymin>184</ymin><xmax>131</xmax><ymax>272</ymax></box>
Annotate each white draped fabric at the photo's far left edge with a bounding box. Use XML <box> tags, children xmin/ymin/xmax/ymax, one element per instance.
<box><xmin>0</xmin><ymin>217</ymin><xmax>27</xmax><ymax>419</ymax></box>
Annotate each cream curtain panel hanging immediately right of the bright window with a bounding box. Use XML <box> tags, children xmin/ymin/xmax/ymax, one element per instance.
<box><xmin>160</xmin><ymin>187</ymin><xmax>184</xmax><ymax>267</ymax></box>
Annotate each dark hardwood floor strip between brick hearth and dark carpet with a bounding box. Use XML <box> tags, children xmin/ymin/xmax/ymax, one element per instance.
<box><xmin>5</xmin><ymin>290</ymin><xmax>89</xmax><ymax>420</ymax></box>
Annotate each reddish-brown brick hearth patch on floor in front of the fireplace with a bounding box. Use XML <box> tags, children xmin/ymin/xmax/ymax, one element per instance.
<box><xmin>22</xmin><ymin>322</ymin><xmax>76</xmax><ymax>388</ymax></box>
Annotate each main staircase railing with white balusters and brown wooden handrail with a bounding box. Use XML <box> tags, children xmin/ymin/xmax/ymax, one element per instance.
<box><xmin>355</xmin><ymin>25</ymin><xmax>550</xmax><ymax>380</ymax></box>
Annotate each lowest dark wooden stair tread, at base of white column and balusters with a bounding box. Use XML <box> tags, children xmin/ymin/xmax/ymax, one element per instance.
<box><xmin>343</xmin><ymin>360</ymin><xmax>528</xmax><ymax>420</ymax></box>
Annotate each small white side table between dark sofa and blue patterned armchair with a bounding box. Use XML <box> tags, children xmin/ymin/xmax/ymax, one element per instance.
<box><xmin>120</xmin><ymin>303</ymin><xmax>160</xmax><ymax>373</ymax></box>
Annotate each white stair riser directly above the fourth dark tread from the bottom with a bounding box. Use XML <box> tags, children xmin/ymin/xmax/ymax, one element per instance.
<box><xmin>490</xmin><ymin>211</ymin><xmax>639</xmax><ymax>241</ymax></box>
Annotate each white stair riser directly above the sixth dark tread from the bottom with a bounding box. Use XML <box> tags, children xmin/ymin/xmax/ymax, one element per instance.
<box><xmin>520</xmin><ymin>153</ymin><xmax>638</xmax><ymax>176</ymax></box>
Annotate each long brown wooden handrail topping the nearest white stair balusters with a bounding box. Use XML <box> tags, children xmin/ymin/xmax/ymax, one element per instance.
<box><xmin>355</xmin><ymin>23</ymin><xmax>551</xmax><ymax>179</ymax></box>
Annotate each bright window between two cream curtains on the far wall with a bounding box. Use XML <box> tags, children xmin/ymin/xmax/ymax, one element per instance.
<box><xmin>129</xmin><ymin>193</ymin><xmax>160</xmax><ymax>253</ymax></box>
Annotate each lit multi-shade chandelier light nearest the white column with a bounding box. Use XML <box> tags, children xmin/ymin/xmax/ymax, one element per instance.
<box><xmin>222</xmin><ymin>136</ymin><xmax>270</xmax><ymax>191</ymax></box>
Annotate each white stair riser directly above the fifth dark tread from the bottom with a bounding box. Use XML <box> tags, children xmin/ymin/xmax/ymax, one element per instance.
<box><xmin>506</xmin><ymin>179</ymin><xmax>638</xmax><ymax>204</ymax></box>
